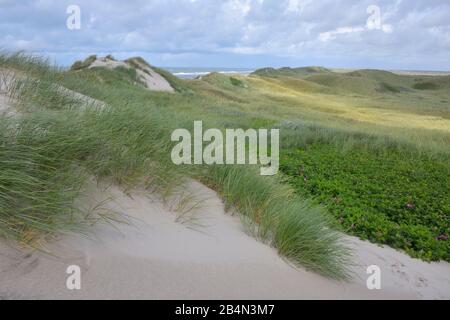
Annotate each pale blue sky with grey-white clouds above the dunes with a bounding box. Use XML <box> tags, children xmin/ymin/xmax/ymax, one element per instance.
<box><xmin>0</xmin><ymin>0</ymin><xmax>450</xmax><ymax>71</ymax></box>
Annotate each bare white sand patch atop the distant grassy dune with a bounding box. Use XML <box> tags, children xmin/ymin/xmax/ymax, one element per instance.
<box><xmin>89</xmin><ymin>57</ymin><xmax>175</xmax><ymax>92</ymax></box>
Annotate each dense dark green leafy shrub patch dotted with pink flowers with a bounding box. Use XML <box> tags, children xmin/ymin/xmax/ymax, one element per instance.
<box><xmin>281</xmin><ymin>143</ymin><xmax>450</xmax><ymax>261</ymax></box>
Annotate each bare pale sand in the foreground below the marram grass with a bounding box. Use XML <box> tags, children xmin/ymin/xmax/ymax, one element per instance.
<box><xmin>0</xmin><ymin>183</ymin><xmax>450</xmax><ymax>299</ymax></box>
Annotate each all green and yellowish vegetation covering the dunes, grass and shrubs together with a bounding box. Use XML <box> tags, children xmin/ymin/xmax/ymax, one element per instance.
<box><xmin>0</xmin><ymin>54</ymin><xmax>450</xmax><ymax>279</ymax></box>
